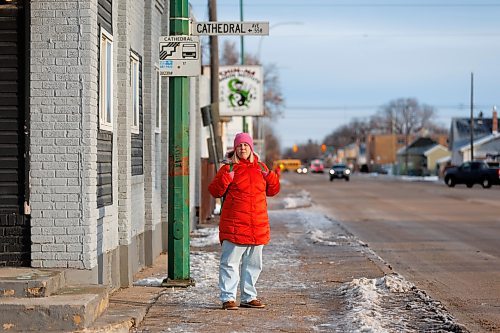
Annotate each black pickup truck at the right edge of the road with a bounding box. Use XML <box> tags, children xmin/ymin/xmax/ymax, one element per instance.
<box><xmin>444</xmin><ymin>161</ymin><xmax>500</xmax><ymax>188</ymax></box>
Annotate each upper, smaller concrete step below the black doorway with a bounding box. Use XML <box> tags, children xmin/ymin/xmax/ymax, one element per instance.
<box><xmin>0</xmin><ymin>267</ymin><xmax>65</xmax><ymax>299</ymax></box>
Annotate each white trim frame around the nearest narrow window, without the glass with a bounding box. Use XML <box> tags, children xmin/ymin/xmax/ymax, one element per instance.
<box><xmin>99</xmin><ymin>27</ymin><xmax>114</xmax><ymax>131</ymax></box>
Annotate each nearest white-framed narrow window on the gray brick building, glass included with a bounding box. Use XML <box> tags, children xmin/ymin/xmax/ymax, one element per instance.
<box><xmin>99</xmin><ymin>28</ymin><xmax>113</xmax><ymax>131</ymax></box>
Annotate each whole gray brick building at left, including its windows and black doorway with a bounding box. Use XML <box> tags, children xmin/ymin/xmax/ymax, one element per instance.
<box><xmin>0</xmin><ymin>0</ymin><xmax>201</xmax><ymax>287</ymax></box>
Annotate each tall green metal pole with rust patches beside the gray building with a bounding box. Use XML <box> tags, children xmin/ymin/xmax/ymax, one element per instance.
<box><xmin>165</xmin><ymin>0</ymin><xmax>192</xmax><ymax>286</ymax></box>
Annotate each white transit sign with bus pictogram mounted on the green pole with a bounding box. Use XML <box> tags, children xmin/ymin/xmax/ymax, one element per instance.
<box><xmin>159</xmin><ymin>35</ymin><xmax>201</xmax><ymax>76</ymax></box>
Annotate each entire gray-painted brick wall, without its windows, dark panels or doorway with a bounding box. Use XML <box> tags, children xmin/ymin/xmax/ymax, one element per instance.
<box><xmin>30</xmin><ymin>0</ymin><xmax>168</xmax><ymax>282</ymax></box>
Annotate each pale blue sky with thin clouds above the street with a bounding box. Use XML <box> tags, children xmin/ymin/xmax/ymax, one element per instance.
<box><xmin>190</xmin><ymin>0</ymin><xmax>500</xmax><ymax>148</ymax></box>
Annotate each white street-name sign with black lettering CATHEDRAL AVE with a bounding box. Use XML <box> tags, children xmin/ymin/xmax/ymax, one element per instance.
<box><xmin>191</xmin><ymin>22</ymin><xmax>269</xmax><ymax>36</ymax></box>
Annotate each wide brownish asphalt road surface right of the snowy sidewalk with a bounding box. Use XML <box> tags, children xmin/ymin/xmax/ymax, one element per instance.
<box><xmin>283</xmin><ymin>173</ymin><xmax>500</xmax><ymax>332</ymax></box>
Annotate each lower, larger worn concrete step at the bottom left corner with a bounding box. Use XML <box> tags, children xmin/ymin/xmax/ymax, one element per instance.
<box><xmin>0</xmin><ymin>285</ymin><xmax>109</xmax><ymax>332</ymax></box>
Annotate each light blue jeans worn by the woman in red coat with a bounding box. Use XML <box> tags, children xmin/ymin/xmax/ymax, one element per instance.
<box><xmin>219</xmin><ymin>240</ymin><xmax>264</xmax><ymax>303</ymax></box>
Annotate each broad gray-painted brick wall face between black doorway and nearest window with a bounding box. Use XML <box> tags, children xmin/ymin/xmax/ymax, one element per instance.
<box><xmin>30</xmin><ymin>0</ymin><xmax>97</xmax><ymax>269</ymax></box>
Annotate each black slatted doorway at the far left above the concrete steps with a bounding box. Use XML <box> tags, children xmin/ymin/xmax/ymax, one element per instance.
<box><xmin>0</xmin><ymin>0</ymin><xmax>31</xmax><ymax>266</ymax></box>
